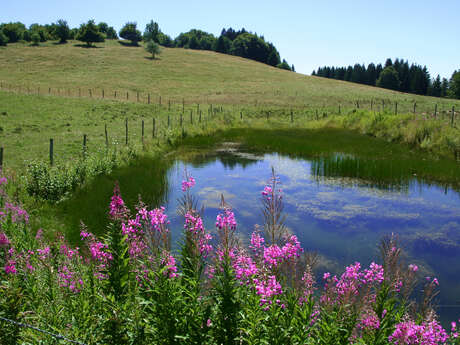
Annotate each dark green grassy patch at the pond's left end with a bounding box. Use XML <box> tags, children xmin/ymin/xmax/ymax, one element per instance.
<box><xmin>56</xmin><ymin>159</ymin><xmax>172</xmax><ymax>241</ymax></box>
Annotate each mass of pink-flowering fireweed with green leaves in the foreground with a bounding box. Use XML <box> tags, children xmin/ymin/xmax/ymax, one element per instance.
<box><xmin>0</xmin><ymin>171</ymin><xmax>460</xmax><ymax>345</ymax></box>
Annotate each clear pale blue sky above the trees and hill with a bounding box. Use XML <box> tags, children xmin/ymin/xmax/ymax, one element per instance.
<box><xmin>0</xmin><ymin>0</ymin><xmax>460</xmax><ymax>78</ymax></box>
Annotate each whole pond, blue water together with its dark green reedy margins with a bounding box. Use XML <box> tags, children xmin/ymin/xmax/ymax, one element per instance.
<box><xmin>58</xmin><ymin>127</ymin><xmax>460</xmax><ymax>320</ymax></box>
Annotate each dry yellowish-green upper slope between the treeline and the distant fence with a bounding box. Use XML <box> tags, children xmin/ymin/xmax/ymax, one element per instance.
<box><xmin>0</xmin><ymin>41</ymin><xmax>460</xmax><ymax>112</ymax></box>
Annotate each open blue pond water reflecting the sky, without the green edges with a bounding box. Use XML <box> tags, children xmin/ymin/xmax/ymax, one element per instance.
<box><xmin>161</xmin><ymin>154</ymin><xmax>460</xmax><ymax>320</ymax></box>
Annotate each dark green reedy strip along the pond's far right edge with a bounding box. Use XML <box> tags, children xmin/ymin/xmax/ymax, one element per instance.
<box><xmin>181</xmin><ymin>128</ymin><xmax>460</xmax><ymax>191</ymax></box>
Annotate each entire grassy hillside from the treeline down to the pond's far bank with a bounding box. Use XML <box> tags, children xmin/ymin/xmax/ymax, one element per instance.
<box><xmin>0</xmin><ymin>41</ymin><xmax>460</xmax><ymax>168</ymax></box>
